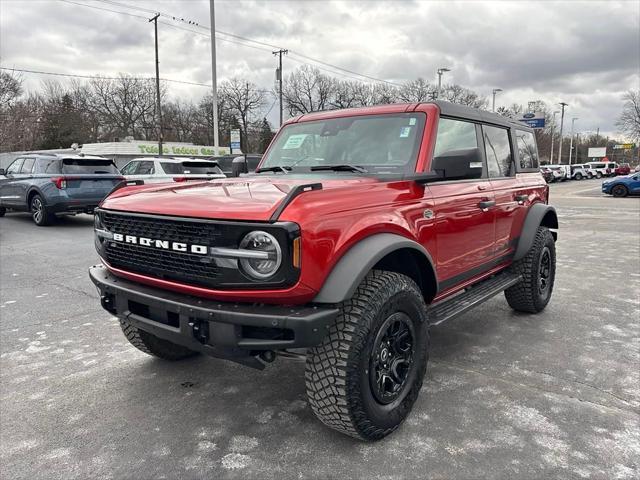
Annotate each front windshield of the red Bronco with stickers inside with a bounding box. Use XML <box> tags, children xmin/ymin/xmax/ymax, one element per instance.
<box><xmin>260</xmin><ymin>113</ymin><xmax>426</xmax><ymax>174</ymax></box>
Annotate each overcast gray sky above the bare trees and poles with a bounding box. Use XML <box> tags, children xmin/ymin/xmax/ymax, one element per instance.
<box><xmin>0</xmin><ymin>0</ymin><xmax>640</xmax><ymax>138</ymax></box>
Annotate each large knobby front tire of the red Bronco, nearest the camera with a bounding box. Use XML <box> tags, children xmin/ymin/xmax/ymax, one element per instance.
<box><xmin>305</xmin><ymin>270</ymin><xmax>429</xmax><ymax>440</ymax></box>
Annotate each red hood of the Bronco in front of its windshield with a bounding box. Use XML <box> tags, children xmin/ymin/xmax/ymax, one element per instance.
<box><xmin>101</xmin><ymin>175</ymin><xmax>377</xmax><ymax>221</ymax></box>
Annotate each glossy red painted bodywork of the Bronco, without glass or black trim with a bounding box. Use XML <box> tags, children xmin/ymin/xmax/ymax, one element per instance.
<box><xmin>102</xmin><ymin>104</ymin><xmax>548</xmax><ymax>305</ymax></box>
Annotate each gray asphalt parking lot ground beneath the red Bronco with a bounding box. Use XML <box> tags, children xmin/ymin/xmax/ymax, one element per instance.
<box><xmin>0</xmin><ymin>180</ymin><xmax>640</xmax><ymax>480</ymax></box>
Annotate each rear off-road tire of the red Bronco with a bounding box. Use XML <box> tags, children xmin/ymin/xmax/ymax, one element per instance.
<box><xmin>504</xmin><ymin>227</ymin><xmax>556</xmax><ymax>313</ymax></box>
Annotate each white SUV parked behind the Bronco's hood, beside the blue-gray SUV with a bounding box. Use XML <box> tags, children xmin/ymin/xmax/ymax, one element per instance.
<box><xmin>120</xmin><ymin>157</ymin><xmax>225</xmax><ymax>183</ymax></box>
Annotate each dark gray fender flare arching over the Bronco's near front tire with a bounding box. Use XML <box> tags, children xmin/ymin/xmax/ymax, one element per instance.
<box><xmin>313</xmin><ymin>233</ymin><xmax>438</xmax><ymax>303</ymax></box>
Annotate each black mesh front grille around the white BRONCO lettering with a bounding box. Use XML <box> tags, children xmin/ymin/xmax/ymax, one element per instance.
<box><xmin>96</xmin><ymin>209</ymin><xmax>299</xmax><ymax>289</ymax></box>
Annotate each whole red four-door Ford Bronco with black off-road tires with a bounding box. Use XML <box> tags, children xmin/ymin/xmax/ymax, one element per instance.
<box><xmin>90</xmin><ymin>102</ymin><xmax>558</xmax><ymax>440</ymax></box>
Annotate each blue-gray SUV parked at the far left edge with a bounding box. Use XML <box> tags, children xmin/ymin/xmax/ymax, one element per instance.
<box><xmin>0</xmin><ymin>154</ymin><xmax>124</xmax><ymax>226</ymax></box>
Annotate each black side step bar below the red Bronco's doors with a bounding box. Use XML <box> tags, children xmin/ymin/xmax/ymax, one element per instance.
<box><xmin>428</xmin><ymin>272</ymin><xmax>522</xmax><ymax>325</ymax></box>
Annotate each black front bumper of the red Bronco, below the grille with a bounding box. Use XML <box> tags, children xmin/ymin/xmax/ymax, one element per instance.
<box><xmin>89</xmin><ymin>265</ymin><xmax>338</xmax><ymax>367</ymax></box>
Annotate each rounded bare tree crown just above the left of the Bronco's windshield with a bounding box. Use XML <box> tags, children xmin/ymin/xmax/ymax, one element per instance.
<box><xmin>282</xmin><ymin>65</ymin><xmax>336</xmax><ymax>115</ymax></box>
